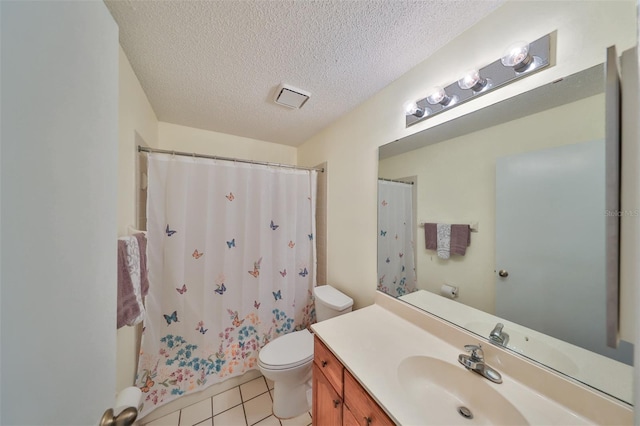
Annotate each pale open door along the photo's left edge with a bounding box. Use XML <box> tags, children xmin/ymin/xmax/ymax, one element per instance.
<box><xmin>0</xmin><ymin>1</ymin><xmax>118</xmax><ymax>425</ymax></box>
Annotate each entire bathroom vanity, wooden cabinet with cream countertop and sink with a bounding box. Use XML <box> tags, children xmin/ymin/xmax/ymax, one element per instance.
<box><xmin>312</xmin><ymin>293</ymin><xmax>633</xmax><ymax>425</ymax></box>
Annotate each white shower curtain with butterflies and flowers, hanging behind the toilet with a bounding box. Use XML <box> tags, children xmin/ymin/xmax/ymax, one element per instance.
<box><xmin>136</xmin><ymin>154</ymin><xmax>317</xmax><ymax>417</ymax></box>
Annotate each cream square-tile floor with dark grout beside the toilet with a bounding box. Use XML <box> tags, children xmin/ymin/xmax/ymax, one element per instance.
<box><xmin>144</xmin><ymin>376</ymin><xmax>311</xmax><ymax>426</ymax></box>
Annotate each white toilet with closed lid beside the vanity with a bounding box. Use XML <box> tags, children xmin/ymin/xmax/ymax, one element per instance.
<box><xmin>258</xmin><ymin>285</ymin><xmax>353</xmax><ymax>419</ymax></box>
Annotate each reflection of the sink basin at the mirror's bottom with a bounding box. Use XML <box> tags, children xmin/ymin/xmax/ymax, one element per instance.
<box><xmin>465</xmin><ymin>321</ymin><xmax>579</xmax><ymax>376</ymax></box>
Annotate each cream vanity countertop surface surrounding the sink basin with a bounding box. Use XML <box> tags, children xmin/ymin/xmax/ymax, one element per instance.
<box><xmin>312</xmin><ymin>305</ymin><xmax>608</xmax><ymax>426</ymax></box>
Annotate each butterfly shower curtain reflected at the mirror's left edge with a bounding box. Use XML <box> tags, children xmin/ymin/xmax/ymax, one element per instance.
<box><xmin>378</xmin><ymin>180</ymin><xmax>416</xmax><ymax>297</ymax></box>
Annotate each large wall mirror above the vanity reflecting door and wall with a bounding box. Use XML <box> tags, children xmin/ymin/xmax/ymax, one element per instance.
<box><xmin>378</xmin><ymin>65</ymin><xmax>633</xmax><ymax>403</ymax></box>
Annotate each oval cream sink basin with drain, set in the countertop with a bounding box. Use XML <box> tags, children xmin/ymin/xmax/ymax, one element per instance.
<box><xmin>398</xmin><ymin>356</ymin><xmax>528</xmax><ymax>425</ymax></box>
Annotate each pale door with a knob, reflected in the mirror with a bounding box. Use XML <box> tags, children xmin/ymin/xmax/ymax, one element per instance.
<box><xmin>496</xmin><ymin>140</ymin><xmax>606</xmax><ymax>352</ymax></box>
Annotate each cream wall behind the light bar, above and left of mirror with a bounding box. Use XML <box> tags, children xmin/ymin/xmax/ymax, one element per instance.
<box><xmin>298</xmin><ymin>0</ymin><xmax>636</xmax><ymax>307</ymax></box>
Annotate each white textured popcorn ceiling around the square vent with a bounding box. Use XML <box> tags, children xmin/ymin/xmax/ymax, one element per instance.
<box><xmin>105</xmin><ymin>0</ymin><xmax>504</xmax><ymax>146</ymax></box>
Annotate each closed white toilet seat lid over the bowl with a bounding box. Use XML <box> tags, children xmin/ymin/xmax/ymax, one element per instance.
<box><xmin>258</xmin><ymin>328</ymin><xmax>313</xmax><ymax>370</ymax></box>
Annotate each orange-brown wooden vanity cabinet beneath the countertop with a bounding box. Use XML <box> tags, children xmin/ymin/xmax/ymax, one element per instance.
<box><xmin>312</xmin><ymin>337</ymin><xmax>394</xmax><ymax>426</ymax></box>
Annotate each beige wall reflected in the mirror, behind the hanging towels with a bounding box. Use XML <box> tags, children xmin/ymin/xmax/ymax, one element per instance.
<box><xmin>378</xmin><ymin>95</ymin><xmax>604</xmax><ymax>314</ymax></box>
